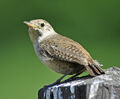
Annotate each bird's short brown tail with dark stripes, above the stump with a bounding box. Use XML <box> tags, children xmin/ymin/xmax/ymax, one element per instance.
<box><xmin>87</xmin><ymin>61</ymin><xmax>105</xmax><ymax>76</ymax></box>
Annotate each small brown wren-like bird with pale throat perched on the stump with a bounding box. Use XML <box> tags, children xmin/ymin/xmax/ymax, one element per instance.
<box><xmin>24</xmin><ymin>19</ymin><xmax>105</xmax><ymax>83</ymax></box>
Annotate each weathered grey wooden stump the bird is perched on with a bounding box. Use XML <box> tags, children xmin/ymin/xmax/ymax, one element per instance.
<box><xmin>38</xmin><ymin>66</ymin><xmax>120</xmax><ymax>99</ymax></box>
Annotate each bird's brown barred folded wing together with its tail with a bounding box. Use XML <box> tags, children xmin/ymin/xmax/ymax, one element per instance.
<box><xmin>40</xmin><ymin>36</ymin><xmax>104</xmax><ymax>76</ymax></box>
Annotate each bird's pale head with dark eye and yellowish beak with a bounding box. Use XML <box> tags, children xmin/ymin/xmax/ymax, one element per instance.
<box><xmin>24</xmin><ymin>19</ymin><xmax>55</xmax><ymax>43</ymax></box>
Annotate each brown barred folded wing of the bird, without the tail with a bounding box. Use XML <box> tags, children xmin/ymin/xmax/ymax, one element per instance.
<box><xmin>41</xmin><ymin>37</ymin><xmax>90</xmax><ymax>65</ymax></box>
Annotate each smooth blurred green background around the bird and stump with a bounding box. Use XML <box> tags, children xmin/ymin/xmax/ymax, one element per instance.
<box><xmin>0</xmin><ymin>0</ymin><xmax>120</xmax><ymax>99</ymax></box>
